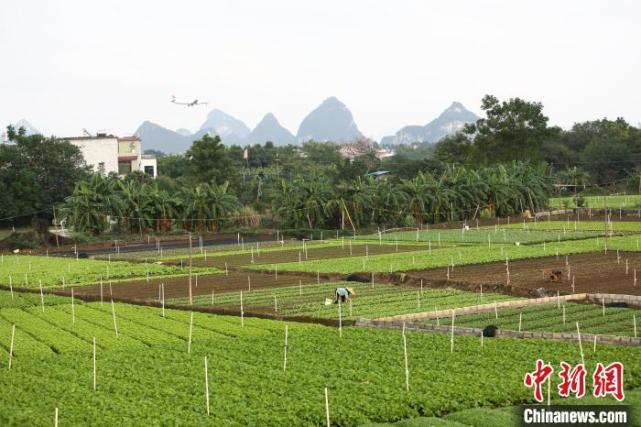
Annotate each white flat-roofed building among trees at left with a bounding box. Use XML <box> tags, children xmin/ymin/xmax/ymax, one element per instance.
<box><xmin>62</xmin><ymin>133</ymin><xmax>158</xmax><ymax>178</ymax></box>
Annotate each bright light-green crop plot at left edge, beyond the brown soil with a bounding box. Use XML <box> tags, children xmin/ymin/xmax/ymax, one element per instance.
<box><xmin>0</xmin><ymin>255</ymin><xmax>216</xmax><ymax>288</ymax></box>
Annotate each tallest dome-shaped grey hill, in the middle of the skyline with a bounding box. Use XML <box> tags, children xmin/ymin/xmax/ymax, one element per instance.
<box><xmin>296</xmin><ymin>96</ymin><xmax>363</xmax><ymax>142</ymax></box>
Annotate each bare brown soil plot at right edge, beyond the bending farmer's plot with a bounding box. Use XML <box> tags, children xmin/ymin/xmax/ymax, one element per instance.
<box><xmin>407</xmin><ymin>251</ymin><xmax>641</xmax><ymax>295</ymax></box>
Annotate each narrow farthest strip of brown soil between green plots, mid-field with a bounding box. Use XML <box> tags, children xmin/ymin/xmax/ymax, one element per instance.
<box><xmin>188</xmin><ymin>243</ymin><xmax>421</xmax><ymax>269</ymax></box>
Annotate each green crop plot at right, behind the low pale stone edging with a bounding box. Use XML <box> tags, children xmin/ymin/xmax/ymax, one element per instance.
<box><xmin>424</xmin><ymin>303</ymin><xmax>641</xmax><ymax>336</ymax></box>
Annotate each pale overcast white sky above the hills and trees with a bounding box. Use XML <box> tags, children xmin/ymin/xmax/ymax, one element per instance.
<box><xmin>0</xmin><ymin>0</ymin><xmax>641</xmax><ymax>139</ymax></box>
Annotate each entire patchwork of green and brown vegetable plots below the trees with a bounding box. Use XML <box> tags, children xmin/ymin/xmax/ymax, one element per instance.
<box><xmin>0</xmin><ymin>220</ymin><xmax>641</xmax><ymax>426</ymax></box>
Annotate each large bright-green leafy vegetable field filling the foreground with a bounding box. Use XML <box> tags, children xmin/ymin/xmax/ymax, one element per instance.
<box><xmin>0</xmin><ymin>296</ymin><xmax>641</xmax><ymax>425</ymax></box>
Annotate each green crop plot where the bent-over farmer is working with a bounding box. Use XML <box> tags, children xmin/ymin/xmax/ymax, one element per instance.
<box><xmin>169</xmin><ymin>282</ymin><xmax>512</xmax><ymax>319</ymax></box>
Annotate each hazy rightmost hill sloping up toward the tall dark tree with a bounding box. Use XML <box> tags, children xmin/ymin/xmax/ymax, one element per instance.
<box><xmin>381</xmin><ymin>102</ymin><xmax>478</xmax><ymax>145</ymax></box>
